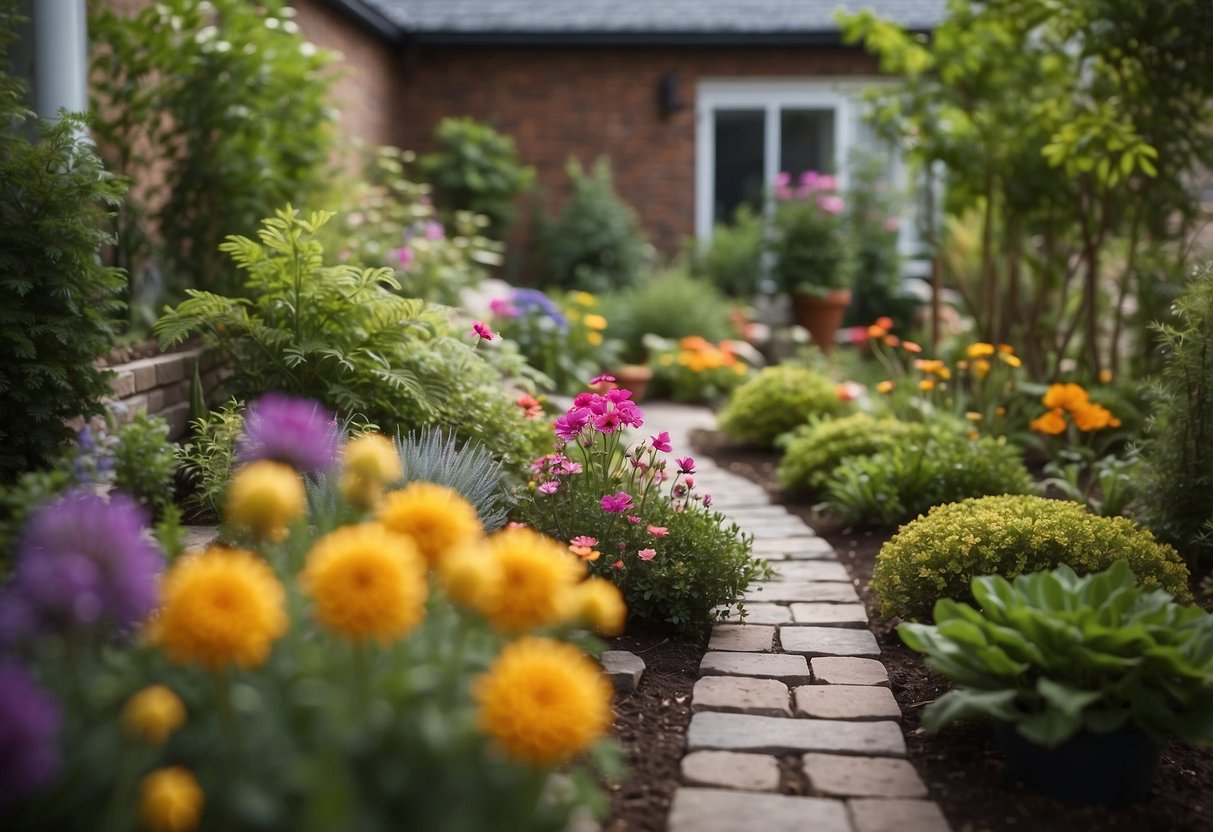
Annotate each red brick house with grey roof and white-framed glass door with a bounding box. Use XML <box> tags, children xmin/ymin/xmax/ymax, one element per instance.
<box><xmin>295</xmin><ymin>0</ymin><xmax>944</xmax><ymax>253</ymax></box>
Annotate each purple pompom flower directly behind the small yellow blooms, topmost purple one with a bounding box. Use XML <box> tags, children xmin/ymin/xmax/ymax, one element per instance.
<box><xmin>237</xmin><ymin>393</ymin><xmax>338</xmax><ymax>474</ymax></box>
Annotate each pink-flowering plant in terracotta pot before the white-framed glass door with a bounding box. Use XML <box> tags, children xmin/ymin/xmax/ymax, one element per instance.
<box><xmin>770</xmin><ymin>171</ymin><xmax>854</xmax><ymax>354</ymax></box>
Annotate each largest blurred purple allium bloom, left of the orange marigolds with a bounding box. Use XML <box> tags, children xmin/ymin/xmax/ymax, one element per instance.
<box><xmin>13</xmin><ymin>494</ymin><xmax>164</xmax><ymax>636</ymax></box>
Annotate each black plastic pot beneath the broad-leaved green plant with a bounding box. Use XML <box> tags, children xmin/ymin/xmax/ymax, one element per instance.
<box><xmin>995</xmin><ymin>723</ymin><xmax>1162</xmax><ymax>805</ymax></box>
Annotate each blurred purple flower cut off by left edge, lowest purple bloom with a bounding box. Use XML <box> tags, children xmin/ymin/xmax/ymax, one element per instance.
<box><xmin>0</xmin><ymin>662</ymin><xmax>61</xmax><ymax>807</ymax></box>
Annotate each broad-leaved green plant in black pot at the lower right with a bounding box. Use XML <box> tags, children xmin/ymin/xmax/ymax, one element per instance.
<box><xmin>898</xmin><ymin>560</ymin><xmax>1213</xmax><ymax>804</ymax></box>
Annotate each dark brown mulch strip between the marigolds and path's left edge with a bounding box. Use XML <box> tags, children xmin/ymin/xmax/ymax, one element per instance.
<box><xmin>603</xmin><ymin>627</ymin><xmax>704</xmax><ymax>832</ymax></box>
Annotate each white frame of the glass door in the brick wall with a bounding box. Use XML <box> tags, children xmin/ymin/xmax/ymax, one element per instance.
<box><xmin>695</xmin><ymin>75</ymin><xmax>905</xmax><ymax>243</ymax></box>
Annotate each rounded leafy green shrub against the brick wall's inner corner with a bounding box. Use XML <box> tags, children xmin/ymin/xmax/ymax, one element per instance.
<box><xmin>420</xmin><ymin>118</ymin><xmax>535</xmax><ymax>240</ymax></box>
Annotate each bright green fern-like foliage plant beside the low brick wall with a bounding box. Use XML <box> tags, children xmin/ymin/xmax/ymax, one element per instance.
<box><xmin>155</xmin><ymin>205</ymin><xmax>446</xmax><ymax>424</ymax></box>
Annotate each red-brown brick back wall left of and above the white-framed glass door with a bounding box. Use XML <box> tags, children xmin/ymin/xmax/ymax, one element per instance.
<box><xmin>393</xmin><ymin>47</ymin><xmax>877</xmax><ymax>255</ymax></box>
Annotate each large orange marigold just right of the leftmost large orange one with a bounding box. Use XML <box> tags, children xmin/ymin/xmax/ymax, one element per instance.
<box><xmin>300</xmin><ymin>523</ymin><xmax>428</xmax><ymax>642</ymax></box>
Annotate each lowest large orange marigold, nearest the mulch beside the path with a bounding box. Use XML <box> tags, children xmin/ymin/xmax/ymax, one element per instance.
<box><xmin>472</xmin><ymin>638</ymin><xmax>611</xmax><ymax>765</ymax></box>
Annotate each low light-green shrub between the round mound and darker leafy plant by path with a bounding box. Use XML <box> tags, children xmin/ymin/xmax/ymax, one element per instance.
<box><xmin>776</xmin><ymin>414</ymin><xmax>912</xmax><ymax>491</ymax></box>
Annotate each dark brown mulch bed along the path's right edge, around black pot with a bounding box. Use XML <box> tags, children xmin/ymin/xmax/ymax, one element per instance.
<box><xmin>693</xmin><ymin>432</ymin><xmax>1213</xmax><ymax>832</ymax></box>
